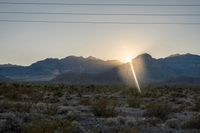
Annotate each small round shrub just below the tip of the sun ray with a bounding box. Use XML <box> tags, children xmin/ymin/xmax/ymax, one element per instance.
<box><xmin>127</xmin><ymin>96</ymin><xmax>142</xmax><ymax>108</ymax></box>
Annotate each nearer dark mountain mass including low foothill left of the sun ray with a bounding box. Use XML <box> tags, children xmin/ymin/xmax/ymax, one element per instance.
<box><xmin>52</xmin><ymin>53</ymin><xmax>200</xmax><ymax>84</ymax></box>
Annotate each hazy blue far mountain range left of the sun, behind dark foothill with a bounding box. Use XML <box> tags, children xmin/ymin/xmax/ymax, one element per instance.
<box><xmin>0</xmin><ymin>56</ymin><xmax>122</xmax><ymax>81</ymax></box>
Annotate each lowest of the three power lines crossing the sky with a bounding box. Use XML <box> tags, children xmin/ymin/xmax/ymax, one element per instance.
<box><xmin>0</xmin><ymin>19</ymin><xmax>200</xmax><ymax>25</ymax></box>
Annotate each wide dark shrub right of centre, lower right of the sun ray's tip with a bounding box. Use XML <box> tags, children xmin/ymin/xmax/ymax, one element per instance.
<box><xmin>144</xmin><ymin>103</ymin><xmax>172</xmax><ymax>119</ymax></box>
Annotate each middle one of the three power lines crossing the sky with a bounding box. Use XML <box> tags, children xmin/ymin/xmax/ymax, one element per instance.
<box><xmin>0</xmin><ymin>12</ymin><xmax>200</xmax><ymax>16</ymax></box>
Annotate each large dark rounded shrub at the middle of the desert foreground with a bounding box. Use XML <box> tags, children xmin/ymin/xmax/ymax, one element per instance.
<box><xmin>92</xmin><ymin>98</ymin><xmax>117</xmax><ymax>117</ymax></box>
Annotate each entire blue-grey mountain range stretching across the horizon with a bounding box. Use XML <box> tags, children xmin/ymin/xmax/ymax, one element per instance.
<box><xmin>0</xmin><ymin>54</ymin><xmax>200</xmax><ymax>84</ymax></box>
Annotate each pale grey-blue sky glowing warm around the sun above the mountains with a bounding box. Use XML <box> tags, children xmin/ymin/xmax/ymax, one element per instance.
<box><xmin>0</xmin><ymin>0</ymin><xmax>200</xmax><ymax>65</ymax></box>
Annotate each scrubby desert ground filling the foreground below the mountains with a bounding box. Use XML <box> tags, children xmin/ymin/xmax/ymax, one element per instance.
<box><xmin>0</xmin><ymin>83</ymin><xmax>200</xmax><ymax>133</ymax></box>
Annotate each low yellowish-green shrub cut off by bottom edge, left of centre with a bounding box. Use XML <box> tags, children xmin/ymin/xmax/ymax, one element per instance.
<box><xmin>22</xmin><ymin>119</ymin><xmax>73</xmax><ymax>133</ymax></box>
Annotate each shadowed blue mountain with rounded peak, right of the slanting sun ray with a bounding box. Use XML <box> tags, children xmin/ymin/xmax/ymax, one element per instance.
<box><xmin>119</xmin><ymin>54</ymin><xmax>200</xmax><ymax>84</ymax></box>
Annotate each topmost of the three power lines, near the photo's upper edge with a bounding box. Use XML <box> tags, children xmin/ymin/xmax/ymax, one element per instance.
<box><xmin>0</xmin><ymin>2</ymin><xmax>200</xmax><ymax>7</ymax></box>
